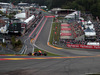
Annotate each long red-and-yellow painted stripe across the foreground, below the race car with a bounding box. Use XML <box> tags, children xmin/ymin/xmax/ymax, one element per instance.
<box><xmin>0</xmin><ymin>55</ymin><xmax>100</xmax><ymax>61</ymax></box>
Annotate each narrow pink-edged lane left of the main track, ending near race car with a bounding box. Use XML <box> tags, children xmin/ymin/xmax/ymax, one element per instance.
<box><xmin>24</xmin><ymin>17</ymin><xmax>45</xmax><ymax>54</ymax></box>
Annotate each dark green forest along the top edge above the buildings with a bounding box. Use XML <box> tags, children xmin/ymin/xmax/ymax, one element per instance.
<box><xmin>0</xmin><ymin>0</ymin><xmax>100</xmax><ymax>18</ymax></box>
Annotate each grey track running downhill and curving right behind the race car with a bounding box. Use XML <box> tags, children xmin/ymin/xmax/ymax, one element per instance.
<box><xmin>35</xmin><ymin>18</ymin><xmax>100</xmax><ymax>56</ymax></box>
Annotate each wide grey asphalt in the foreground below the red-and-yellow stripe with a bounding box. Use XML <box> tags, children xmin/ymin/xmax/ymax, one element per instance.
<box><xmin>0</xmin><ymin>57</ymin><xmax>100</xmax><ymax>75</ymax></box>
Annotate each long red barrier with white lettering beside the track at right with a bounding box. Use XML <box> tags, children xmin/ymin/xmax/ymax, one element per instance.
<box><xmin>67</xmin><ymin>44</ymin><xmax>100</xmax><ymax>49</ymax></box>
